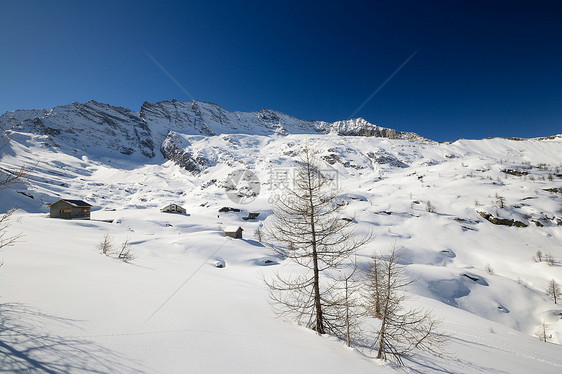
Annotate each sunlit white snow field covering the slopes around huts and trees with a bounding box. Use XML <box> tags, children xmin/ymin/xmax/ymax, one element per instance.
<box><xmin>0</xmin><ymin>133</ymin><xmax>562</xmax><ymax>373</ymax></box>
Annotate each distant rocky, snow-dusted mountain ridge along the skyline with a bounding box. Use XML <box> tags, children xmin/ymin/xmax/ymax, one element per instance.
<box><xmin>0</xmin><ymin>100</ymin><xmax>427</xmax><ymax>159</ymax></box>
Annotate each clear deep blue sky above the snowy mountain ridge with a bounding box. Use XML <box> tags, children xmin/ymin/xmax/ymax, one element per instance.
<box><xmin>0</xmin><ymin>0</ymin><xmax>562</xmax><ymax>140</ymax></box>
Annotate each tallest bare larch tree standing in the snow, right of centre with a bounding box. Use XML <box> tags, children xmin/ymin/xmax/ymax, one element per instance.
<box><xmin>266</xmin><ymin>147</ymin><xmax>368</xmax><ymax>334</ymax></box>
